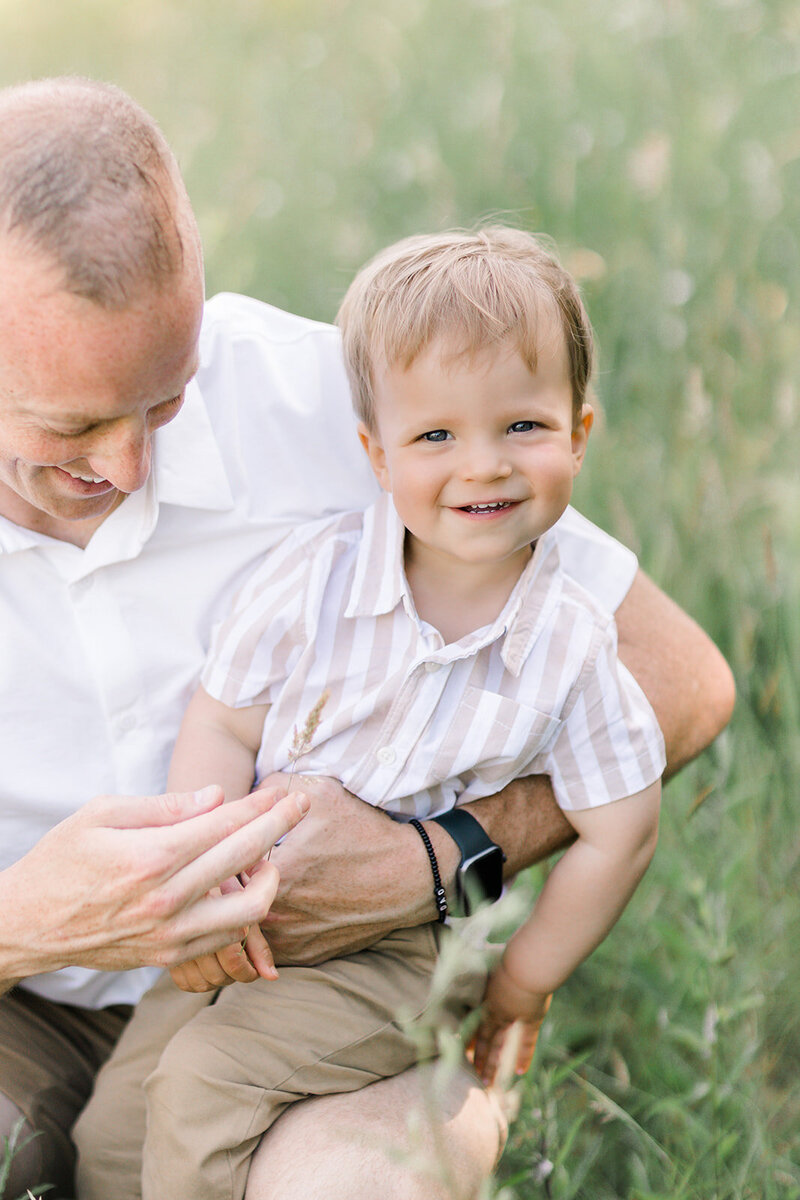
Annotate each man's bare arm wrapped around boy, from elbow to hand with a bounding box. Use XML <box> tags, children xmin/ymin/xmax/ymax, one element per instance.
<box><xmin>266</xmin><ymin>571</ymin><xmax>734</xmax><ymax>965</ymax></box>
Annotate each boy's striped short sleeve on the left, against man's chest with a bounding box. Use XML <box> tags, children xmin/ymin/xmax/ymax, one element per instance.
<box><xmin>200</xmin><ymin>534</ymin><xmax>313</xmax><ymax>708</ymax></box>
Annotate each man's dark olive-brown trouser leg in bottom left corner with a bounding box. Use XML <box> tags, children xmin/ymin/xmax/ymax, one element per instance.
<box><xmin>0</xmin><ymin>988</ymin><xmax>131</xmax><ymax>1200</ymax></box>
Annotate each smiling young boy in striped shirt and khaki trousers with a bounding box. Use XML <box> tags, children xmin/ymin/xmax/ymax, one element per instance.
<box><xmin>94</xmin><ymin>228</ymin><xmax>664</xmax><ymax>1200</ymax></box>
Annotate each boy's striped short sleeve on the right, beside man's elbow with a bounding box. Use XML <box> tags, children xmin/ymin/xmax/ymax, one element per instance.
<box><xmin>535</xmin><ymin>624</ymin><xmax>667</xmax><ymax>811</ymax></box>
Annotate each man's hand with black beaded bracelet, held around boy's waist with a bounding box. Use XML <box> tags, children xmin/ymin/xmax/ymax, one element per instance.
<box><xmin>263</xmin><ymin>774</ymin><xmax>448</xmax><ymax>966</ymax></box>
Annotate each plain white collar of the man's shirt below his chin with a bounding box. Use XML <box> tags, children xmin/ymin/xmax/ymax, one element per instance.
<box><xmin>0</xmin><ymin>380</ymin><xmax>234</xmax><ymax>570</ymax></box>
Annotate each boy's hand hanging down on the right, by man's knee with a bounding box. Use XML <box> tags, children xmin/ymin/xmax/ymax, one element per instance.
<box><xmin>470</xmin><ymin>961</ymin><xmax>553</xmax><ymax>1087</ymax></box>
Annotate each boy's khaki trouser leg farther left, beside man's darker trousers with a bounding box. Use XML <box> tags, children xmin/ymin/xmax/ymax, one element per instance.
<box><xmin>72</xmin><ymin>973</ymin><xmax>217</xmax><ymax>1200</ymax></box>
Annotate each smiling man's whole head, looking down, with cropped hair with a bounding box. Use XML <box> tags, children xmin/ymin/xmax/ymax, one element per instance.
<box><xmin>0</xmin><ymin>79</ymin><xmax>203</xmax><ymax>541</ymax></box>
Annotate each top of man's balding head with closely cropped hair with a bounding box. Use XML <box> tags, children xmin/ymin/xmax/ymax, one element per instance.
<box><xmin>0</xmin><ymin>78</ymin><xmax>199</xmax><ymax>308</ymax></box>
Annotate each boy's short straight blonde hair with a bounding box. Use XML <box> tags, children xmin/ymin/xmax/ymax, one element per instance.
<box><xmin>336</xmin><ymin>226</ymin><xmax>594</xmax><ymax>430</ymax></box>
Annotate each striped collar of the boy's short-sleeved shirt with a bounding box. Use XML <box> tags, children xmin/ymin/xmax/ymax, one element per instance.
<box><xmin>344</xmin><ymin>492</ymin><xmax>563</xmax><ymax>676</ymax></box>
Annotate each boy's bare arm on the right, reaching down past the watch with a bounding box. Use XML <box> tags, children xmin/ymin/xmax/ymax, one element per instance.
<box><xmin>474</xmin><ymin>782</ymin><xmax>661</xmax><ymax>1084</ymax></box>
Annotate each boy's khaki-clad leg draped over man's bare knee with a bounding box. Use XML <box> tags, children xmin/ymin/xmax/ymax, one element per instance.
<box><xmin>140</xmin><ymin>926</ymin><xmax>480</xmax><ymax>1200</ymax></box>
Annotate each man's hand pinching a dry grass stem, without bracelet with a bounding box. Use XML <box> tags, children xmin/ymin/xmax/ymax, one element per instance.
<box><xmin>0</xmin><ymin>787</ymin><xmax>308</xmax><ymax>990</ymax></box>
